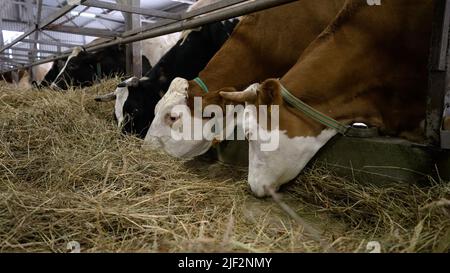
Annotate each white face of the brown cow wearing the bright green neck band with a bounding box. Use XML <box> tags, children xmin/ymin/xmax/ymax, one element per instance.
<box><xmin>143</xmin><ymin>78</ymin><xmax>212</xmax><ymax>158</ymax></box>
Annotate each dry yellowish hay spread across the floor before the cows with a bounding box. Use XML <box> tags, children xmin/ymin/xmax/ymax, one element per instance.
<box><xmin>0</xmin><ymin>79</ymin><xmax>450</xmax><ymax>252</ymax></box>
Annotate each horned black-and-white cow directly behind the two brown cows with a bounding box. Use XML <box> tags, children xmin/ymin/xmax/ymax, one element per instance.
<box><xmin>96</xmin><ymin>19</ymin><xmax>239</xmax><ymax>138</ymax></box>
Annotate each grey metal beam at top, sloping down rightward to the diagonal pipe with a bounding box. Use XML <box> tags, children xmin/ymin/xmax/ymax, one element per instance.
<box><xmin>83</xmin><ymin>0</ymin><xmax>181</xmax><ymax>20</ymax></box>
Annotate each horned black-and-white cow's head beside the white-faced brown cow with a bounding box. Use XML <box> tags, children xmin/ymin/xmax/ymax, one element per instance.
<box><xmin>95</xmin><ymin>77</ymin><xmax>161</xmax><ymax>138</ymax></box>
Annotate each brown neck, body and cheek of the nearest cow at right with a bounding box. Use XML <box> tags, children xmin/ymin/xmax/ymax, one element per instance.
<box><xmin>270</xmin><ymin>0</ymin><xmax>433</xmax><ymax>140</ymax></box>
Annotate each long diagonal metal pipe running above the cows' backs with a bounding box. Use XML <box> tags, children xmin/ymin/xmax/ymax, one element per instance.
<box><xmin>0</xmin><ymin>0</ymin><xmax>297</xmax><ymax>72</ymax></box>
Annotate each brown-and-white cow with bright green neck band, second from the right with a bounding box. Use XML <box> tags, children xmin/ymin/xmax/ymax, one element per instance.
<box><xmin>145</xmin><ymin>0</ymin><xmax>345</xmax><ymax>152</ymax></box>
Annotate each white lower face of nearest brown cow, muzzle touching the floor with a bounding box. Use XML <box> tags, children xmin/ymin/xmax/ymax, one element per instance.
<box><xmin>248</xmin><ymin>129</ymin><xmax>336</xmax><ymax>197</ymax></box>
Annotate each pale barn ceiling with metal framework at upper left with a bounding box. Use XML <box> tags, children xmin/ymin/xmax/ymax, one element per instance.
<box><xmin>0</xmin><ymin>0</ymin><xmax>197</xmax><ymax>71</ymax></box>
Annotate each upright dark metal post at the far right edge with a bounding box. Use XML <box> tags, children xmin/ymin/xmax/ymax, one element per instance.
<box><xmin>425</xmin><ymin>0</ymin><xmax>450</xmax><ymax>146</ymax></box>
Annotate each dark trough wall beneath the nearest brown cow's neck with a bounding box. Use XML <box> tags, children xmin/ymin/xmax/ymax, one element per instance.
<box><xmin>216</xmin><ymin>136</ymin><xmax>450</xmax><ymax>185</ymax></box>
